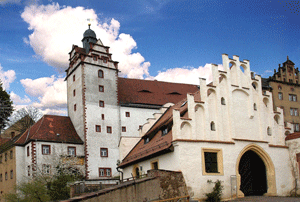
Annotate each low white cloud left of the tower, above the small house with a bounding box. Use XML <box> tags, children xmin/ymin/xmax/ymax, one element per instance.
<box><xmin>20</xmin><ymin>76</ymin><xmax>67</xmax><ymax>113</ymax></box>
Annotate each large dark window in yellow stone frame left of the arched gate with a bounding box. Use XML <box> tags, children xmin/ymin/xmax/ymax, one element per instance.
<box><xmin>202</xmin><ymin>149</ymin><xmax>223</xmax><ymax>175</ymax></box>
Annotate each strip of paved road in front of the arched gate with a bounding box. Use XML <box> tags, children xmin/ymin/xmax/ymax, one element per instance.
<box><xmin>230</xmin><ymin>196</ymin><xmax>300</xmax><ymax>202</ymax></box>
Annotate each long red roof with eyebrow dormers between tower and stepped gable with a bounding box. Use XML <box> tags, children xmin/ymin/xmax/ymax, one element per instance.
<box><xmin>118</xmin><ymin>77</ymin><xmax>199</xmax><ymax>106</ymax></box>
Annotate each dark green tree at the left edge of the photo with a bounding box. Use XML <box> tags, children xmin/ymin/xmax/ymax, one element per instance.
<box><xmin>0</xmin><ymin>81</ymin><xmax>13</xmax><ymax>131</ymax></box>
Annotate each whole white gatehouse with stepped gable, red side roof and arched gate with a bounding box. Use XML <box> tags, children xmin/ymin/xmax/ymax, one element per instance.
<box><xmin>119</xmin><ymin>54</ymin><xmax>294</xmax><ymax>200</ymax></box>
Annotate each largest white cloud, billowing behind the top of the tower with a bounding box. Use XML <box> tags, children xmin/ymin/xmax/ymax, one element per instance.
<box><xmin>21</xmin><ymin>3</ymin><xmax>150</xmax><ymax>78</ymax></box>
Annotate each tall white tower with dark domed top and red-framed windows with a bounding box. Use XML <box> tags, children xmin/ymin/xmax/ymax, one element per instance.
<box><xmin>66</xmin><ymin>27</ymin><xmax>120</xmax><ymax>179</ymax></box>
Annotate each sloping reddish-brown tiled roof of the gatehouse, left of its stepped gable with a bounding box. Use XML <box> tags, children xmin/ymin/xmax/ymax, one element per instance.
<box><xmin>119</xmin><ymin>91</ymin><xmax>200</xmax><ymax>168</ymax></box>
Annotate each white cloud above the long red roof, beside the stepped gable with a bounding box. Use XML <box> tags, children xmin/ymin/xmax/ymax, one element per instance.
<box><xmin>148</xmin><ymin>64</ymin><xmax>223</xmax><ymax>85</ymax></box>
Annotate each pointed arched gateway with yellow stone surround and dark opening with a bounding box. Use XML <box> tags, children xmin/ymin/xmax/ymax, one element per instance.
<box><xmin>236</xmin><ymin>144</ymin><xmax>276</xmax><ymax>197</ymax></box>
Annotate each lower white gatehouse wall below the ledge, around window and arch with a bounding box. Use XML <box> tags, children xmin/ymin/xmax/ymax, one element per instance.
<box><xmin>123</xmin><ymin>141</ymin><xmax>293</xmax><ymax>199</ymax></box>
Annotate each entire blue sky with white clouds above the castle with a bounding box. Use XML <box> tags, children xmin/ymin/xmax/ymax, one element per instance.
<box><xmin>0</xmin><ymin>0</ymin><xmax>300</xmax><ymax>115</ymax></box>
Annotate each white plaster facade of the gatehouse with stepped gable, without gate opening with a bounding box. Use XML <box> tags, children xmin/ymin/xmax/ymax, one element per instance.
<box><xmin>121</xmin><ymin>54</ymin><xmax>294</xmax><ymax>199</ymax></box>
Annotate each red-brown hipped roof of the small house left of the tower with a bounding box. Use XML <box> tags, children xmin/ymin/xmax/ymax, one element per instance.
<box><xmin>15</xmin><ymin>115</ymin><xmax>83</xmax><ymax>145</ymax></box>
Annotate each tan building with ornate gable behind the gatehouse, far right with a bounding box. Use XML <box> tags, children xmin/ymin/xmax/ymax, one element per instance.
<box><xmin>268</xmin><ymin>57</ymin><xmax>300</xmax><ymax>131</ymax></box>
